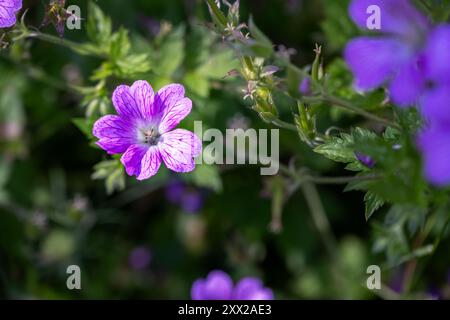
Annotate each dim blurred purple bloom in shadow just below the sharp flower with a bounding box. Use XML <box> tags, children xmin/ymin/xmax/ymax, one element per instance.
<box><xmin>166</xmin><ymin>181</ymin><xmax>204</xmax><ymax>213</ymax></box>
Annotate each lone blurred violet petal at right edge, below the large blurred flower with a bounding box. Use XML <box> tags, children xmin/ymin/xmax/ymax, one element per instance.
<box><xmin>418</xmin><ymin>124</ymin><xmax>450</xmax><ymax>186</ymax></box>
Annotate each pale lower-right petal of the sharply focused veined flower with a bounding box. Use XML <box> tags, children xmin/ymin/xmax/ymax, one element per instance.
<box><xmin>158</xmin><ymin>129</ymin><xmax>202</xmax><ymax>172</ymax></box>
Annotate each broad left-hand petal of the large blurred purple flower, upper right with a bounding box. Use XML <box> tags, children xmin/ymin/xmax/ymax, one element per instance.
<box><xmin>344</xmin><ymin>37</ymin><xmax>411</xmax><ymax>90</ymax></box>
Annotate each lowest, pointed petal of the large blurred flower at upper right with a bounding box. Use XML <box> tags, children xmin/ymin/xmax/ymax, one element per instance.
<box><xmin>389</xmin><ymin>57</ymin><xmax>426</xmax><ymax>107</ymax></box>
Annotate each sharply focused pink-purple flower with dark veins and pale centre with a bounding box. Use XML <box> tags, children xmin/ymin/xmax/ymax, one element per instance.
<box><xmin>93</xmin><ymin>81</ymin><xmax>202</xmax><ymax>180</ymax></box>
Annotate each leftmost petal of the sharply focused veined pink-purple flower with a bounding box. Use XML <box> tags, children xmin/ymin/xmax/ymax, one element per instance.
<box><xmin>92</xmin><ymin>115</ymin><xmax>133</xmax><ymax>154</ymax></box>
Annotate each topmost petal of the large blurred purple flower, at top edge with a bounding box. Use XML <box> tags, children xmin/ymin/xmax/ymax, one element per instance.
<box><xmin>349</xmin><ymin>0</ymin><xmax>430</xmax><ymax>37</ymax></box>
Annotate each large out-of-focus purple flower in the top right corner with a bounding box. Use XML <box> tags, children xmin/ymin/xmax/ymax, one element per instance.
<box><xmin>344</xmin><ymin>0</ymin><xmax>430</xmax><ymax>106</ymax></box>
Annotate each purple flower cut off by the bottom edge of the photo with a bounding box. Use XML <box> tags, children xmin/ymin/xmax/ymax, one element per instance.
<box><xmin>191</xmin><ymin>270</ymin><xmax>274</xmax><ymax>300</ymax></box>
